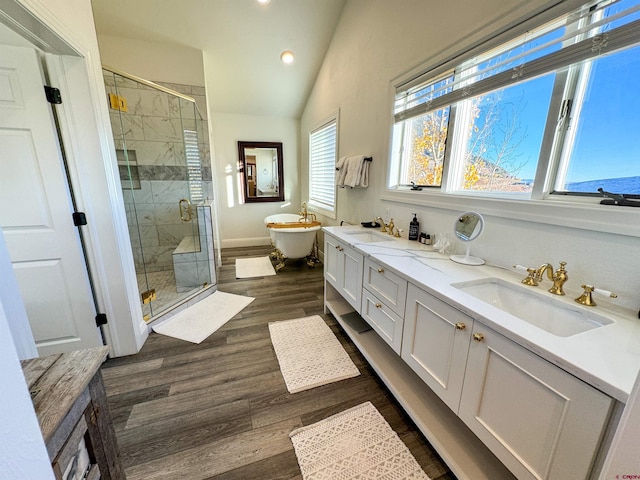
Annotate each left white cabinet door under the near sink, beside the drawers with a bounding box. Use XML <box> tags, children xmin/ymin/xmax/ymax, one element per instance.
<box><xmin>402</xmin><ymin>284</ymin><xmax>473</xmax><ymax>413</ymax></box>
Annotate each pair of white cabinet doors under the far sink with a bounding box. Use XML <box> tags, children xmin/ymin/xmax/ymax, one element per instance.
<box><xmin>324</xmin><ymin>232</ymin><xmax>363</xmax><ymax>313</ymax></box>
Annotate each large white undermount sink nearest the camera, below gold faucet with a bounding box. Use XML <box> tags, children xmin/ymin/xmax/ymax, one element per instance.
<box><xmin>451</xmin><ymin>278</ymin><xmax>613</xmax><ymax>337</ymax></box>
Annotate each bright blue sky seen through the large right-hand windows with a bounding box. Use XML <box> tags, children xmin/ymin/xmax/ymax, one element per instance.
<box><xmin>468</xmin><ymin>0</ymin><xmax>640</xmax><ymax>189</ymax></box>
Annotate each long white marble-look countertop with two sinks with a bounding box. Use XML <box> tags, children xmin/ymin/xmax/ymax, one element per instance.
<box><xmin>323</xmin><ymin>226</ymin><xmax>640</xmax><ymax>403</ymax></box>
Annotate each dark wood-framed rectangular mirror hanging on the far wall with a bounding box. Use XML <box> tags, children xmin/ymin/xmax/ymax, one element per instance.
<box><xmin>238</xmin><ymin>142</ymin><xmax>284</xmax><ymax>203</ymax></box>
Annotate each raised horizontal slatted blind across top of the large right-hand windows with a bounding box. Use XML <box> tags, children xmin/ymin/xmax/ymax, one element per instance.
<box><xmin>394</xmin><ymin>1</ymin><xmax>640</xmax><ymax>122</ymax></box>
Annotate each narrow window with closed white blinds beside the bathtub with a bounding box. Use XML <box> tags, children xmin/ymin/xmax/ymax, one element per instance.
<box><xmin>309</xmin><ymin>112</ymin><xmax>338</xmax><ymax>218</ymax></box>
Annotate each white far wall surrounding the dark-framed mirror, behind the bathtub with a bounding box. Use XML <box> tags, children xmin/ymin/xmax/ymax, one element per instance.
<box><xmin>205</xmin><ymin>112</ymin><xmax>302</xmax><ymax>247</ymax></box>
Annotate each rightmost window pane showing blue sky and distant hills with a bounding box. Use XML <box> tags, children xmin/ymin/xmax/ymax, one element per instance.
<box><xmin>555</xmin><ymin>41</ymin><xmax>640</xmax><ymax>195</ymax></box>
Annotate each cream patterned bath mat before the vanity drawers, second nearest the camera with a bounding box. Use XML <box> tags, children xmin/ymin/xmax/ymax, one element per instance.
<box><xmin>269</xmin><ymin>315</ymin><xmax>360</xmax><ymax>393</ymax></box>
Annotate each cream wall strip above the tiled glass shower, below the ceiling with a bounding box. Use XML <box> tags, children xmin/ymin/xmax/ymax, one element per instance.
<box><xmin>98</xmin><ymin>35</ymin><xmax>205</xmax><ymax>86</ymax></box>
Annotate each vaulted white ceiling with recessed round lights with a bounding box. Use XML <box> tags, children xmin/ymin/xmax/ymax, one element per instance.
<box><xmin>92</xmin><ymin>0</ymin><xmax>346</xmax><ymax>118</ymax></box>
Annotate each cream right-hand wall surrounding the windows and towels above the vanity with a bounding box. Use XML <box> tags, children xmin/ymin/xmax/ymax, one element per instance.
<box><xmin>300</xmin><ymin>0</ymin><xmax>640</xmax><ymax>310</ymax></box>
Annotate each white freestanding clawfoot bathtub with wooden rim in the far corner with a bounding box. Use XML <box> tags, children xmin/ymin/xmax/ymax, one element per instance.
<box><xmin>264</xmin><ymin>213</ymin><xmax>321</xmax><ymax>271</ymax></box>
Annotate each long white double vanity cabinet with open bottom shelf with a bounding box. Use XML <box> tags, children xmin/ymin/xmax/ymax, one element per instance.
<box><xmin>324</xmin><ymin>231</ymin><xmax>620</xmax><ymax>480</ymax></box>
